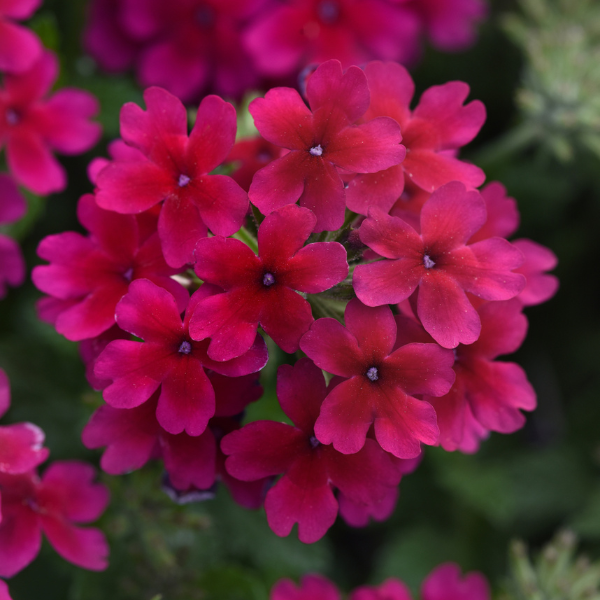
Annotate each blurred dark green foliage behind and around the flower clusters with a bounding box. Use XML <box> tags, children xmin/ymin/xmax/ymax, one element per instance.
<box><xmin>0</xmin><ymin>0</ymin><xmax>600</xmax><ymax>600</ymax></box>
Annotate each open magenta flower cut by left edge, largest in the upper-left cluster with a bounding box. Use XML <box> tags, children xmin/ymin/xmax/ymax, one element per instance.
<box><xmin>0</xmin><ymin>51</ymin><xmax>101</xmax><ymax>195</ymax></box>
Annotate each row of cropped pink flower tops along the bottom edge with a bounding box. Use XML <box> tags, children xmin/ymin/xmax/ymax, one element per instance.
<box><xmin>270</xmin><ymin>563</ymin><xmax>491</xmax><ymax>600</ymax></box>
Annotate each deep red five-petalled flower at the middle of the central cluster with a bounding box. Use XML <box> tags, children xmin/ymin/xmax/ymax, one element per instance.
<box><xmin>190</xmin><ymin>205</ymin><xmax>348</xmax><ymax>361</ymax></box>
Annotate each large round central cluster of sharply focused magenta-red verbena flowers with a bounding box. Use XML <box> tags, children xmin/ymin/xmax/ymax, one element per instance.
<box><xmin>33</xmin><ymin>58</ymin><xmax>557</xmax><ymax>548</ymax></box>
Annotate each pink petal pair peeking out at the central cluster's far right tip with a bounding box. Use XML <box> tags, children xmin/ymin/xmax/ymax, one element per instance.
<box><xmin>513</xmin><ymin>239</ymin><xmax>558</xmax><ymax>306</ymax></box>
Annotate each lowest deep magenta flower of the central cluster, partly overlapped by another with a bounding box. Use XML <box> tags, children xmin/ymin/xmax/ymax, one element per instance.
<box><xmin>221</xmin><ymin>358</ymin><xmax>400</xmax><ymax>544</ymax></box>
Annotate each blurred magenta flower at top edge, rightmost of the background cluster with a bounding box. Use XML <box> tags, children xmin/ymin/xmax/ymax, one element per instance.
<box><xmin>407</xmin><ymin>0</ymin><xmax>488</xmax><ymax>52</ymax></box>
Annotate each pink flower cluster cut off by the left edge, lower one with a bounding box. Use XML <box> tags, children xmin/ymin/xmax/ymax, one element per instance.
<box><xmin>0</xmin><ymin>369</ymin><xmax>108</xmax><ymax>598</ymax></box>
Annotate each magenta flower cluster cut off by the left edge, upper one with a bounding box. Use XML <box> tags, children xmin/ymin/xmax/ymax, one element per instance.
<box><xmin>0</xmin><ymin>0</ymin><xmax>101</xmax><ymax>298</ymax></box>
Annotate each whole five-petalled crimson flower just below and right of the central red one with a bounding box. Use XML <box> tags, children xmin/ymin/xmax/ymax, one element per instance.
<box><xmin>300</xmin><ymin>300</ymin><xmax>454</xmax><ymax>460</ymax></box>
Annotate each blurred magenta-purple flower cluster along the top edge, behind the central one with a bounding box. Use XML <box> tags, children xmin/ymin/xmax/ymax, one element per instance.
<box><xmin>84</xmin><ymin>0</ymin><xmax>486</xmax><ymax>102</ymax></box>
